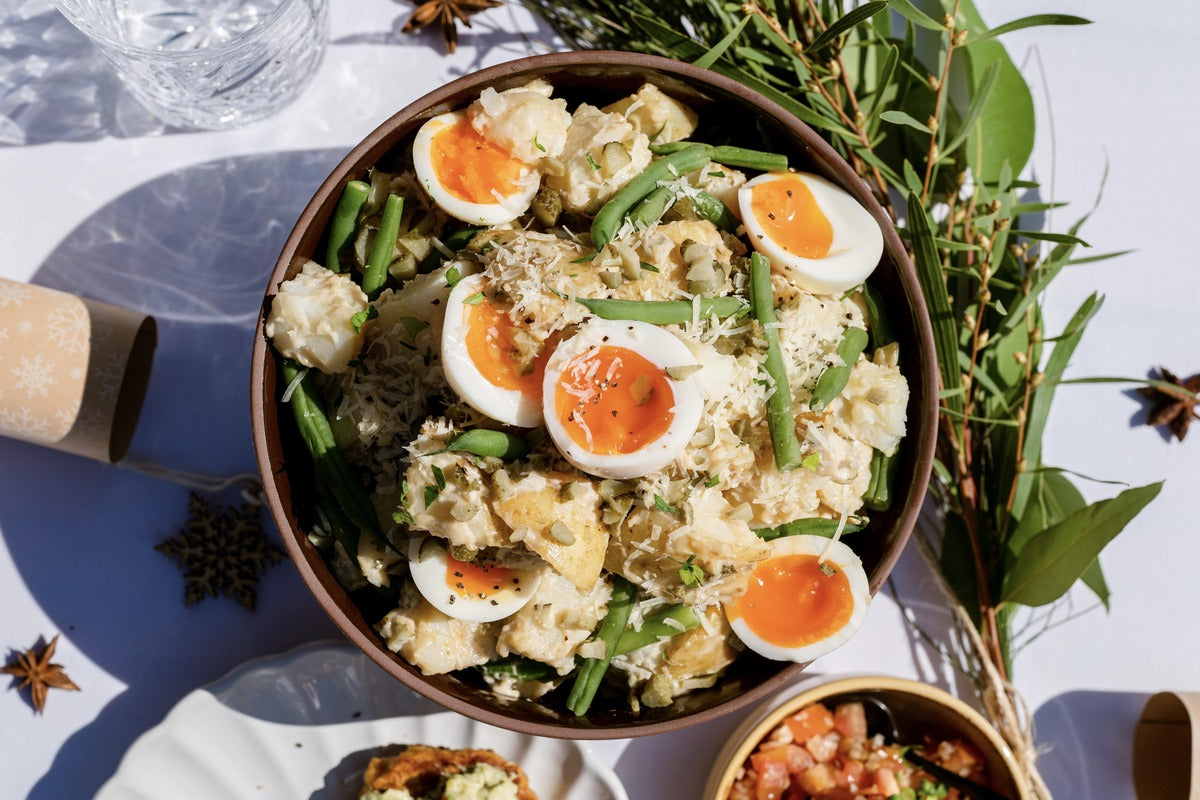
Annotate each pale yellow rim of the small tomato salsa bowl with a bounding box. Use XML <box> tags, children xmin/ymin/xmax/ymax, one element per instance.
<box><xmin>701</xmin><ymin>674</ymin><xmax>1033</xmax><ymax>800</ymax></box>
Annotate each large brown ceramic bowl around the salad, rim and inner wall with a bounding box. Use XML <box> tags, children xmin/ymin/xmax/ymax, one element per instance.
<box><xmin>251</xmin><ymin>52</ymin><xmax>937</xmax><ymax>739</ymax></box>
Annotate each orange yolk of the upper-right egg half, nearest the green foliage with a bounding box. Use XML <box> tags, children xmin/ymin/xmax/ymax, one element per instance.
<box><xmin>750</xmin><ymin>174</ymin><xmax>833</xmax><ymax>258</ymax></box>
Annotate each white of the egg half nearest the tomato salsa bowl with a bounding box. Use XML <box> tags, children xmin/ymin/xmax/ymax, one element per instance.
<box><xmin>730</xmin><ymin>535</ymin><xmax>871</xmax><ymax>663</ymax></box>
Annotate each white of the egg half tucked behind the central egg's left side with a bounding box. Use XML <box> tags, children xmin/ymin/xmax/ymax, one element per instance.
<box><xmin>442</xmin><ymin>273</ymin><xmax>541</xmax><ymax>428</ymax></box>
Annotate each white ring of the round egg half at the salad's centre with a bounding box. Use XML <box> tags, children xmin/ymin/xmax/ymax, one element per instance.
<box><xmin>541</xmin><ymin>319</ymin><xmax>704</xmax><ymax>479</ymax></box>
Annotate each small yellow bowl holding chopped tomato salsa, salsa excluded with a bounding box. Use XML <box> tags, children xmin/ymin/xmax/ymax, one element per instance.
<box><xmin>701</xmin><ymin>675</ymin><xmax>1033</xmax><ymax>800</ymax></box>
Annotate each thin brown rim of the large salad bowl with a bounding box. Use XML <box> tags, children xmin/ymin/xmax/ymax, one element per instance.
<box><xmin>250</xmin><ymin>50</ymin><xmax>938</xmax><ymax>739</ymax></box>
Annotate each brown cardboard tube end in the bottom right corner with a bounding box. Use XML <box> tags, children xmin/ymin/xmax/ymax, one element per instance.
<box><xmin>1133</xmin><ymin>692</ymin><xmax>1200</xmax><ymax>800</ymax></box>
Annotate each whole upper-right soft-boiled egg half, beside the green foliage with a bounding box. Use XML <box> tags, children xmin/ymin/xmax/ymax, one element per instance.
<box><xmin>738</xmin><ymin>173</ymin><xmax>883</xmax><ymax>294</ymax></box>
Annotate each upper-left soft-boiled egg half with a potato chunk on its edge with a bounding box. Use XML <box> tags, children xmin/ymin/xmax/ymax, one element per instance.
<box><xmin>413</xmin><ymin>112</ymin><xmax>541</xmax><ymax>225</ymax></box>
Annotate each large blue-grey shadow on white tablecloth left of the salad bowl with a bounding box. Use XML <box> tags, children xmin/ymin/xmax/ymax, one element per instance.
<box><xmin>0</xmin><ymin>150</ymin><xmax>343</xmax><ymax>800</ymax></box>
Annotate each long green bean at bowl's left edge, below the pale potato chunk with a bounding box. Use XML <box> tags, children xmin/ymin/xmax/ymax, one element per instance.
<box><xmin>282</xmin><ymin>360</ymin><xmax>383</xmax><ymax>537</ymax></box>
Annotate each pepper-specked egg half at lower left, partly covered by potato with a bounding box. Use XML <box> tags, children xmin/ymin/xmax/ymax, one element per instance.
<box><xmin>408</xmin><ymin>536</ymin><xmax>541</xmax><ymax>622</ymax></box>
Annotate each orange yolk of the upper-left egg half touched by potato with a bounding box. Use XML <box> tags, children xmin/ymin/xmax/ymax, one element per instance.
<box><xmin>430</xmin><ymin>116</ymin><xmax>526</xmax><ymax>205</ymax></box>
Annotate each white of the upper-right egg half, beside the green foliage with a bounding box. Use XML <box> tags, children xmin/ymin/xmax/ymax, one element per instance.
<box><xmin>738</xmin><ymin>173</ymin><xmax>883</xmax><ymax>294</ymax></box>
